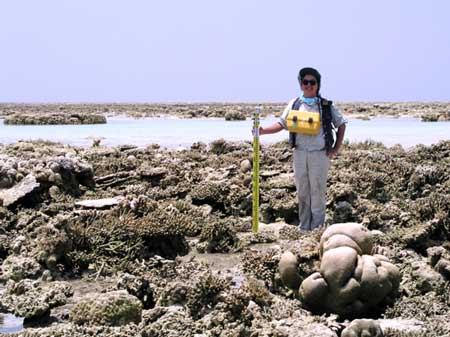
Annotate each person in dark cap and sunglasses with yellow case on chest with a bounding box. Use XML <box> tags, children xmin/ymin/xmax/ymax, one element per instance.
<box><xmin>259</xmin><ymin>67</ymin><xmax>347</xmax><ymax>231</ymax></box>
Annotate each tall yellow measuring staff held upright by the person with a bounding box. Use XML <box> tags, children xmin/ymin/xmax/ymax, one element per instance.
<box><xmin>252</xmin><ymin>108</ymin><xmax>261</xmax><ymax>233</ymax></box>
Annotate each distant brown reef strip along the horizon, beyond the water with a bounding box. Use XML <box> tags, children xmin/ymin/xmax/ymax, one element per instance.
<box><xmin>0</xmin><ymin>102</ymin><xmax>450</xmax><ymax>121</ymax></box>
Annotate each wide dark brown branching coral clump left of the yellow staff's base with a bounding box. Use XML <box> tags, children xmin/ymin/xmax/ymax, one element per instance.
<box><xmin>69</xmin><ymin>208</ymin><xmax>189</xmax><ymax>272</ymax></box>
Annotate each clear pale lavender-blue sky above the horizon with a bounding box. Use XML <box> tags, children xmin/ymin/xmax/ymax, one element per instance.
<box><xmin>0</xmin><ymin>0</ymin><xmax>450</xmax><ymax>102</ymax></box>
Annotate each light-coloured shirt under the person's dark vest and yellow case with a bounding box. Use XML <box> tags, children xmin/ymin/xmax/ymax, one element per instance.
<box><xmin>279</xmin><ymin>98</ymin><xmax>347</xmax><ymax>151</ymax></box>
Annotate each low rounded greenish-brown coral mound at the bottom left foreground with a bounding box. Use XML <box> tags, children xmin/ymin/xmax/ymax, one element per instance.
<box><xmin>69</xmin><ymin>290</ymin><xmax>142</xmax><ymax>326</ymax></box>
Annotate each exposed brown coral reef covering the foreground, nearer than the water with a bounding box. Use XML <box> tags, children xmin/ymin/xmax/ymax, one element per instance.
<box><xmin>0</xmin><ymin>140</ymin><xmax>450</xmax><ymax>337</ymax></box>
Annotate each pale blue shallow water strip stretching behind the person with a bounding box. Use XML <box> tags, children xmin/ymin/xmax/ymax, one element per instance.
<box><xmin>0</xmin><ymin>116</ymin><xmax>450</xmax><ymax>148</ymax></box>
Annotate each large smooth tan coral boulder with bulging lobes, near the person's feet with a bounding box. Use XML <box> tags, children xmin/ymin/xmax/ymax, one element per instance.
<box><xmin>300</xmin><ymin>223</ymin><xmax>401</xmax><ymax>317</ymax></box>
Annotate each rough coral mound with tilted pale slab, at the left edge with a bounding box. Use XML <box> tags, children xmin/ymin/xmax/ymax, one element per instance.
<box><xmin>0</xmin><ymin>150</ymin><xmax>95</xmax><ymax>208</ymax></box>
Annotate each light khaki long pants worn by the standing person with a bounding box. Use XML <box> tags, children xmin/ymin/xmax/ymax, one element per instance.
<box><xmin>294</xmin><ymin>150</ymin><xmax>330</xmax><ymax>230</ymax></box>
